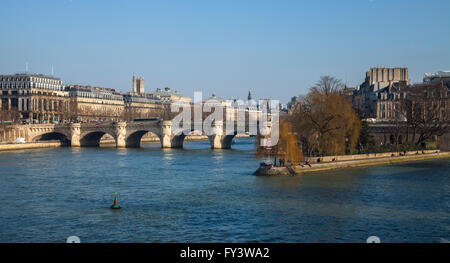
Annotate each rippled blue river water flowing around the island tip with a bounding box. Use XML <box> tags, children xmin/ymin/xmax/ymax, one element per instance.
<box><xmin>0</xmin><ymin>139</ymin><xmax>450</xmax><ymax>242</ymax></box>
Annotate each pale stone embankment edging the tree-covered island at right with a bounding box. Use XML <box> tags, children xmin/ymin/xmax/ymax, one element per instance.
<box><xmin>255</xmin><ymin>150</ymin><xmax>450</xmax><ymax>176</ymax></box>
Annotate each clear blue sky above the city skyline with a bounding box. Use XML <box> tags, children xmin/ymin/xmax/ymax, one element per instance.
<box><xmin>0</xmin><ymin>0</ymin><xmax>450</xmax><ymax>102</ymax></box>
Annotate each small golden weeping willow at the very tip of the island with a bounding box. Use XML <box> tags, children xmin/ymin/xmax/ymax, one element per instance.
<box><xmin>256</xmin><ymin>120</ymin><xmax>303</xmax><ymax>165</ymax></box>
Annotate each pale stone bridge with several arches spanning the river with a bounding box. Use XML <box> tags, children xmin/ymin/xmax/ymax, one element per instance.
<box><xmin>22</xmin><ymin>120</ymin><xmax>271</xmax><ymax>149</ymax></box>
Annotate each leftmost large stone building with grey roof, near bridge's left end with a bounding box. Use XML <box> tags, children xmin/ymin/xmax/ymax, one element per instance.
<box><xmin>0</xmin><ymin>73</ymin><xmax>70</xmax><ymax>123</ymax></box>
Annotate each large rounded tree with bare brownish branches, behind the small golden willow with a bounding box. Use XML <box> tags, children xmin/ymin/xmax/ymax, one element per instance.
<box><xmin>291</xmin><ymin>77</ymin><xmax>361</xmax><ymax>156</ymax></box>
